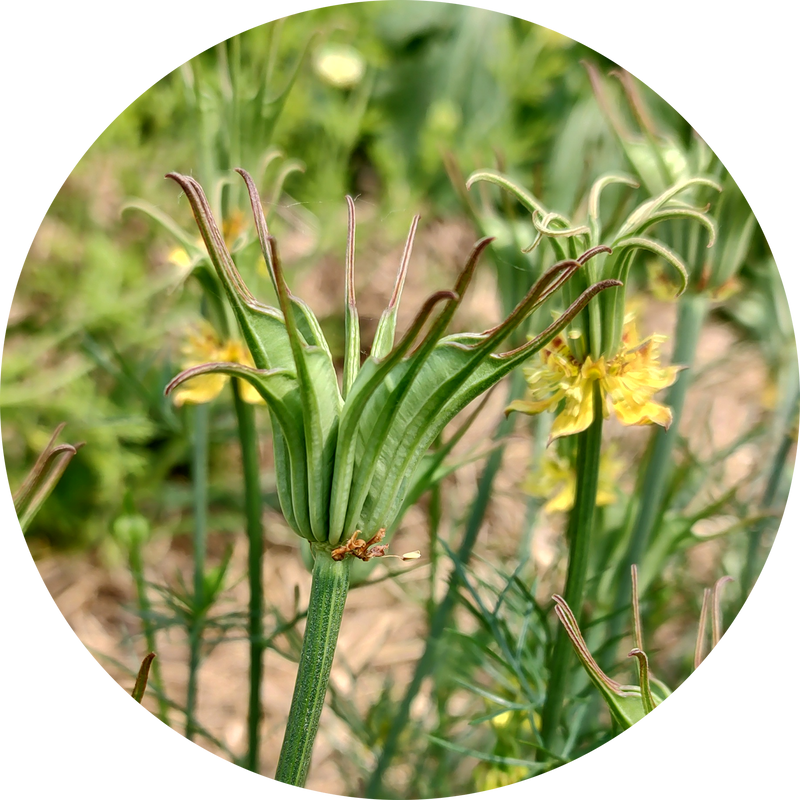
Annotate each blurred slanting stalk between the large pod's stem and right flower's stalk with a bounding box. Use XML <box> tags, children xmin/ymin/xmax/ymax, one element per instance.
<box><xmin>364</xmin><ymin>370</ymin><xmax>525</xmax><ymax>800</ymax></box>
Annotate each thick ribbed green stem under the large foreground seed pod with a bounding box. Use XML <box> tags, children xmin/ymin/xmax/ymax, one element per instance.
<box><xmin>275</xmin><ymin>544</ymin><xmax>352</xmax><ymax>790</ymax></box>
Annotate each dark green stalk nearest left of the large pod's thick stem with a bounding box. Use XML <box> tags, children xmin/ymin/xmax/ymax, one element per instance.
<box><xmin>231</xmin><ymin>380</ymin><xmax>264</xmax><ymax>776</ymax></box>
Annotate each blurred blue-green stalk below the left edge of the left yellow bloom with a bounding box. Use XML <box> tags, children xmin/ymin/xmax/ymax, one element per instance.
<box><xmin>185</xmin><ymin>403</ymin><xmax>209</xmax><ymax>744</ymax></box>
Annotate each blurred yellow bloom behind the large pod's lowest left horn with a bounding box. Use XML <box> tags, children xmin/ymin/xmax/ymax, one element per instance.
<box><xmin>173</xmin><ymin>321</ymin><xmax>264</xmax><ymax>406</ymax></box>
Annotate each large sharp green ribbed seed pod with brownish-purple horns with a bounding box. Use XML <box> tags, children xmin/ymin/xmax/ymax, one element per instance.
<box><xmin>165</xmin><ymin>170</ymin><xmax>620</xmax><ymax>560</ymax></box>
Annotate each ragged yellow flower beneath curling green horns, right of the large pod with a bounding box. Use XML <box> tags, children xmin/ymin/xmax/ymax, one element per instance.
<box><xmin>506</xmin><ymin>323</ymin><xmax>682</xmax><ymax>442</ymax></box>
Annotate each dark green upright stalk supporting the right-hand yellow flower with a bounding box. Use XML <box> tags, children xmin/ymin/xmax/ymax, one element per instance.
<box><xmin>542</xmin><ymin>384</ymin><xmax>603</xmax><ymax>751</ymax></box>
